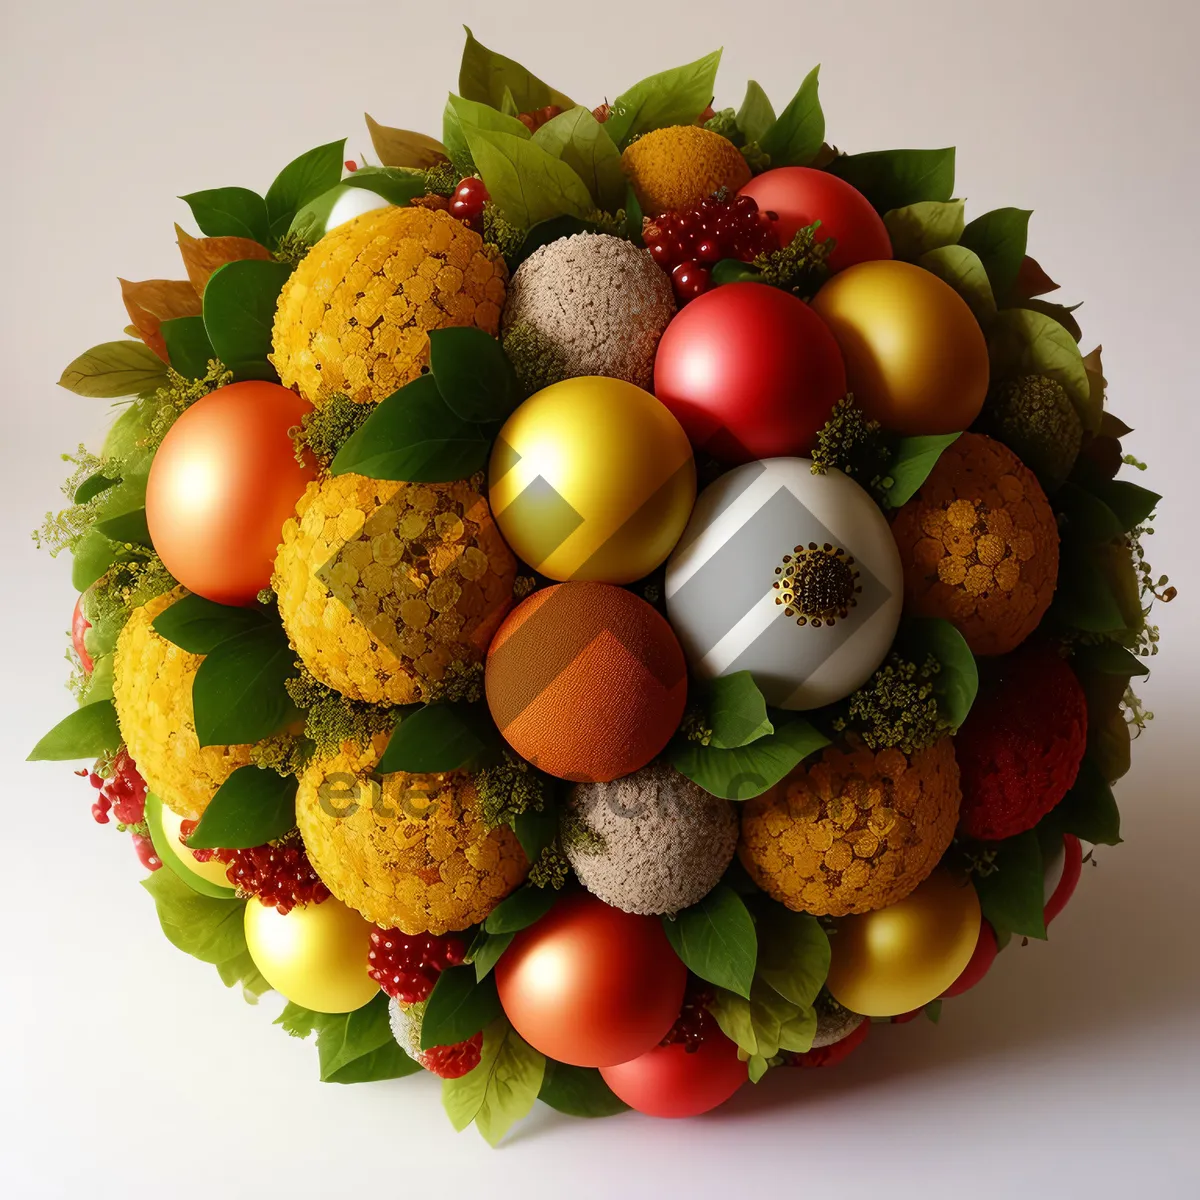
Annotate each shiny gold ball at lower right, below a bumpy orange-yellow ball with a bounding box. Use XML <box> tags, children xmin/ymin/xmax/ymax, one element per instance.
<box><xmin>826</xmin><ymin>868</ymin><xmax>982</xmax><ymax>1016</ymax></box>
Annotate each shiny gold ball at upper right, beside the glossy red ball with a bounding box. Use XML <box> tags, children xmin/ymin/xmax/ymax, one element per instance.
<box><xmin>812</xmin><ymin>259</ymin><xmax>989</xmax><ymax>436</ymax></box>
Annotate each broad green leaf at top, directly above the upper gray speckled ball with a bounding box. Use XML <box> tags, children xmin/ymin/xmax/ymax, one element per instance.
<box><xmin>463</xmin><ymin>125</ymin><xmax>595</xmax><ymax>229</ymax></box>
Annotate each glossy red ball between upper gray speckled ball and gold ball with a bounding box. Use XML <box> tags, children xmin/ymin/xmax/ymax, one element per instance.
<box><xmin>654</xmin><ymin>283</ymin><xmax>846</xmax><ymax>463</ymax></box>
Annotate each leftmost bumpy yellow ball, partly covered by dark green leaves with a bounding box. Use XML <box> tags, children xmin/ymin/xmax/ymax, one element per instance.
<box><xmin>113</xmin><ymin>588</ymin><xmax>251</xmax><ymax>817</ymax></box>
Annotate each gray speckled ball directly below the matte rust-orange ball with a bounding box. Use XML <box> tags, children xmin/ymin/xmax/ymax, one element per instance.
<box><xmin>563</xmin><ymin>762</ymin><xmax>738</xmax><ymax>914</ymax></box>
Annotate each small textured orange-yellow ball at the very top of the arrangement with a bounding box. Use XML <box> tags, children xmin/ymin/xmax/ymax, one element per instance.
<box><xmin>620</xmin><ymin>125</ymin><xmax>750</xmax><ymax>217</ymax></box>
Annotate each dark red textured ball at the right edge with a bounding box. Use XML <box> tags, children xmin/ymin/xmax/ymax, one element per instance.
<box><xmin>954</xmin><ymin>642</ymin><xmax>1087</xmax><ymax>841</ymax></box>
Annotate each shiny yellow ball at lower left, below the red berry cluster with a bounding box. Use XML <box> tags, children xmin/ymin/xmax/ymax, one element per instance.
<box><xmin>245</xmin><ymin>896</ymin><xmax>379</xmax><ymax>1013</ymax></box>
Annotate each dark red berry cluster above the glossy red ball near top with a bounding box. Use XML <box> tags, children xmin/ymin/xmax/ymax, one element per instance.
<box><xmin>646</xmin><ymin>192</ymin><xmax>779</xmax><ymax>304</ymax></box>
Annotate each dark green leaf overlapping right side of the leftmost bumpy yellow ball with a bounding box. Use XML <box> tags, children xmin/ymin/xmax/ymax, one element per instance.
<box><xmin>192</xmin><ymin>625</ymin><xmax>299</xmax><ymax>746</ymax></box>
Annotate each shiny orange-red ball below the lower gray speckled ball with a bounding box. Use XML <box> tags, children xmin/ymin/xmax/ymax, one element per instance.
<box><xmin>496</xmin><ymin>892</ymin><xmax>688</xmax><ymax>1067</ymax></box>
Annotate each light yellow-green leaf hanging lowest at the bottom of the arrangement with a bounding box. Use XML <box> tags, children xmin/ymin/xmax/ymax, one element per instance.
<box><xmin>442</xmin><ymin>1020</ymin><xmax>546</xmax><ymax>1146</ymax></box>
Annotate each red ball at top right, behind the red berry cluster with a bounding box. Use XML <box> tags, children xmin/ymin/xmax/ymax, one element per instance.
<box><xmin>738</xmin><ymin>167</ymin><xmax>892</xmax><ymax>271</ymax></box>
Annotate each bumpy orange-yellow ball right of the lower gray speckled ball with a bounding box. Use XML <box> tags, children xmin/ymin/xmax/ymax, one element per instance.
<box><xmin>738</xmin><ymin>738</ymin><xmax>962</xmax><ymax>917</ymax></box>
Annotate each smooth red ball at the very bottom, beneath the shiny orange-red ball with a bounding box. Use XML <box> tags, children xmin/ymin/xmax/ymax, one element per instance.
<box><xmin>600</xmin><ymin>1033</ymin><xmax>749</xmax><ymax>1117</ymax></box>
